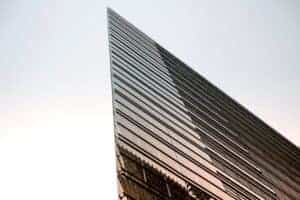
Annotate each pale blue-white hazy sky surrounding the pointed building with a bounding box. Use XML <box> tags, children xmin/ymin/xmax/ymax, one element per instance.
<box><xmin>0</xmin><ymin>0</ymin><xmax>300</xmax><ymax>200</ymax></box>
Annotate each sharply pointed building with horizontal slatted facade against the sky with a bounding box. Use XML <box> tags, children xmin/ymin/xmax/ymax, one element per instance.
<box><xmin>108</xmin><ymin>9</ymin><xmax>300</xmax><ymax>200</ymax></box>
